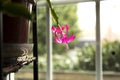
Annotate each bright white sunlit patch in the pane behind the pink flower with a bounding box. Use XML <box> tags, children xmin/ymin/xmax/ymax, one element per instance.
<box><xmin>77</xmin><ymin>2</ymin><xmax>95</xmax><ymax>38</ymax></box>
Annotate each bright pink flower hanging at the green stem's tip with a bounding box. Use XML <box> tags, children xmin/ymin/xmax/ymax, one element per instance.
<box><xmin>52</xmin><ymin>24</ymin><xmax>75</xmax><ymax>48</ymax></box>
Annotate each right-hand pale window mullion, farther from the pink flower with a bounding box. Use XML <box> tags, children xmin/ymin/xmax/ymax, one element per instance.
<box><xmin>96</xmin><ymin>0</ymin><xmax>103</xmax><ymax>80</ymax></box>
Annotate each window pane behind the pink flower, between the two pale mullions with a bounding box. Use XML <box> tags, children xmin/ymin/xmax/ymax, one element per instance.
<box><xmin>53</xmin><ymin>2</ymin><xmax>95</xmax><ymax>80</ymax></box>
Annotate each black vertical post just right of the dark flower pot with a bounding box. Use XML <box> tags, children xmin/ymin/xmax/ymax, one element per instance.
<box><xmin>32</xmin><ymin>5</ymin><xmax>38</xmax><ymax>80</ymax></box>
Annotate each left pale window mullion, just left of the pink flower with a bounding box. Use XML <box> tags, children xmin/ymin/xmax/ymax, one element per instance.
<box><xmin>46</xmin><ymin>6</ymin><xmax>53</xmax><ymax>80</ymax></box>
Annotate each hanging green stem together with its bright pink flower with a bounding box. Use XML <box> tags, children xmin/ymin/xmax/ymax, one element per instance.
<box><xmin>47</xmin><ymin>0</ymin><xmax>75</xmax><ymax>49</ymax></box>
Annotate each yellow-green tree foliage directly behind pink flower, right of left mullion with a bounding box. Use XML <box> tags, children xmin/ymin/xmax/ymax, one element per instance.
<box><xmin>53</xmin><ymin>4</ymin><xmax>80</xmax><ymax>54</ymax></box>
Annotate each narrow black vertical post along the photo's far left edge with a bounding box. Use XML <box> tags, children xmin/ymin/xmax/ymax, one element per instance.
<box><xmin>0</xmin><ymin>13</ymin><xmax>3</xmax><ymax>80</ymax></box>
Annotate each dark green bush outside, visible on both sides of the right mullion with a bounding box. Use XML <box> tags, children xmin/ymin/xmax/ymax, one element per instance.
<box><xmin>79</xmin><ymin>41</ymin><xmax>120</xmax><ymax>71</ymax></box>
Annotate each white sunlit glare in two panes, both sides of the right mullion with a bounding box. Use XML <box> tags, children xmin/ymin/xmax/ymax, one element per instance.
<box><xmin>78</xmin><ymin>0</ymin><xmax>120</xmax><ymax>40</ymax></box>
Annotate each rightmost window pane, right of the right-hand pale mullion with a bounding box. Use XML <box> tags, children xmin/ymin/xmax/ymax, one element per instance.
<box><xmin>101</xmin><ymin>0</ymin><xmax>120</xmax><ymax>80</ymax></box>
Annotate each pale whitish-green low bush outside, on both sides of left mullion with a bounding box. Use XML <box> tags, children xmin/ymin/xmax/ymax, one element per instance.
<box><xmin>33</xmin><ymin>54</ymin><xmax>78</xmax><ymax>70</ymax></box>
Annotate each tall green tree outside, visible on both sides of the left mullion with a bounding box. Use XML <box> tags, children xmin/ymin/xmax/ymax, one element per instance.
<box><xmin>37</xmin><ymin>5</ymin><xmax>80</xmax><ymax>54</ymax></box>
